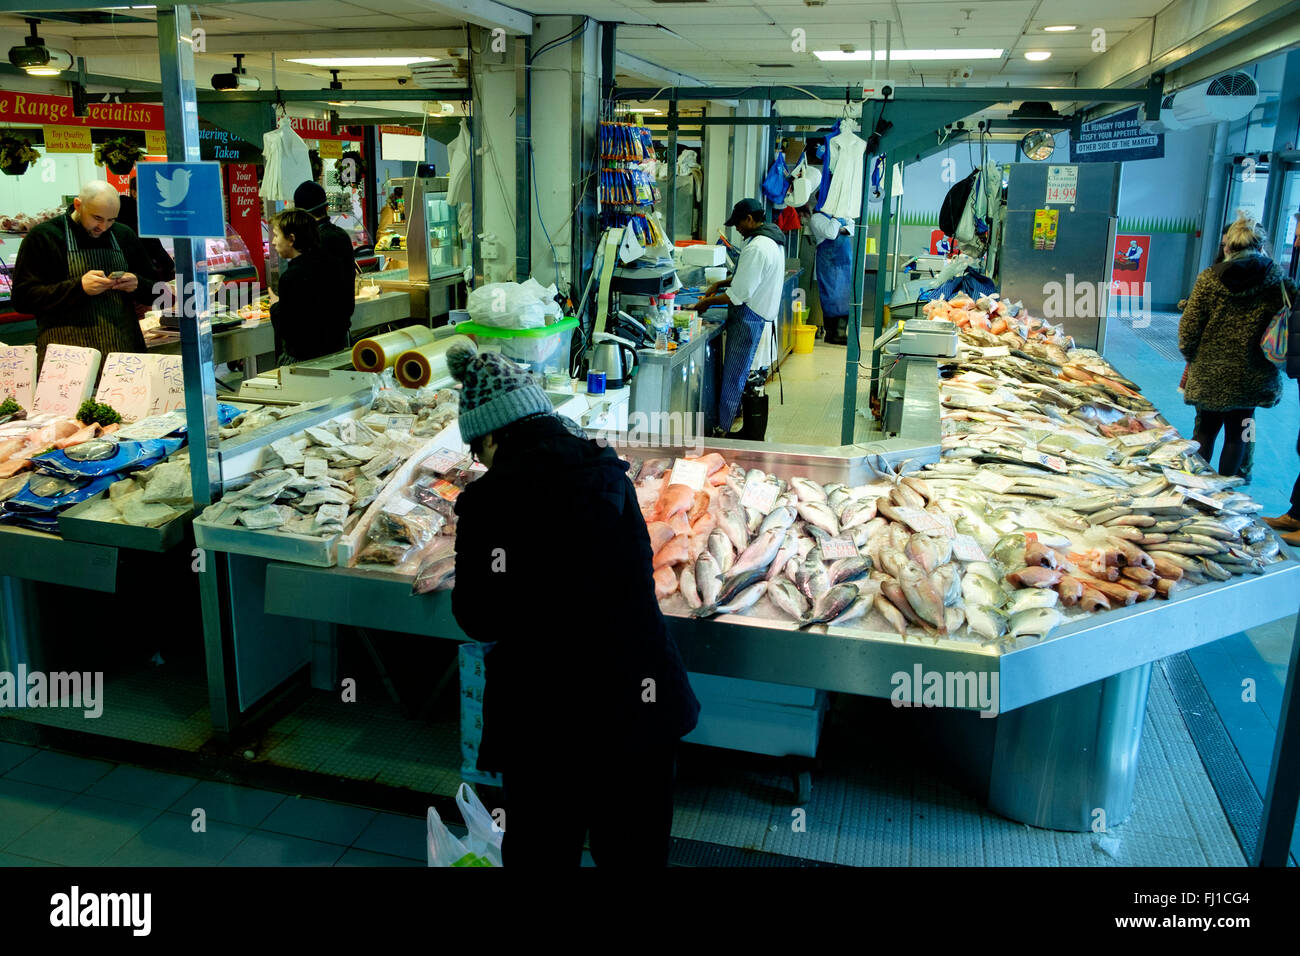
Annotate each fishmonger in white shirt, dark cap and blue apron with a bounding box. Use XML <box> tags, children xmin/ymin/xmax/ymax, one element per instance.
<box><xmin>696</xmin><ymin>199</ymin><xmax>785</xmax><ymax>434</ymax></box>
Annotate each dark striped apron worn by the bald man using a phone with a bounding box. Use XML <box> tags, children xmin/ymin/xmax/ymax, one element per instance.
<box><xmin>36</xmin><ymin>219</ymin><xmax>144</xmax><ymax>364</ymax></box>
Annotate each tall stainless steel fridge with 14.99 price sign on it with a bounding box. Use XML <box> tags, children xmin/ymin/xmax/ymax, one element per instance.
<box><xmin>998</xmin><ymin>163</ymin><xmax>1119</xmax><ymax>351</ymax></box>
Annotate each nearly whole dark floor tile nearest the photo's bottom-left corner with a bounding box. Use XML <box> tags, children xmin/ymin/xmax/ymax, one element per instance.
<box><xmin>5</xmin><ymin>793</ymin><xmax>159</xmax><ymax>866</ymax></box>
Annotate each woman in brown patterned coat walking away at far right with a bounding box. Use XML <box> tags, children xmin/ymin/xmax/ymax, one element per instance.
<box><xmin>1178</xmin><ymin>219</ymin><xmax>1287</xmax><ymax>475</ymax></box>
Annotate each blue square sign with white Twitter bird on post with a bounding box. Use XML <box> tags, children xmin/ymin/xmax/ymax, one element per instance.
<box><xmin>135</xmin><ymin>163</ymin><xmax>226</xmax><ymax>239</ymax></box>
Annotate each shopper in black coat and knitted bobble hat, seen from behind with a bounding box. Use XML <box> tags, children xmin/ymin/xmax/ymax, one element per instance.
<box><xmin>449</xmin><ymin>349</ymin><xmax>699</xmax><ymax>866</ymax></box>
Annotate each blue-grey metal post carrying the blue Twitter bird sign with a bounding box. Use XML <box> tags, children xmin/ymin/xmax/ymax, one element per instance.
<box><xmin>157</xmin><ymin>5</ymin><xmax>239</xmax><ymax>734</ymax></box>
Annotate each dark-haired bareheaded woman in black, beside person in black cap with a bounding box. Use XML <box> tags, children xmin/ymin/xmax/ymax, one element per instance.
<box><xmin>270</xmin><ymin>209</ymin><xmax>348</xmax><ymax>365</ymax></box>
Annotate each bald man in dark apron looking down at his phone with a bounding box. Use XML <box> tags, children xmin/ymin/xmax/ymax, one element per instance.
<box><xmin>13</xmin><ymin>181</ymin><xmax>155</xmax><ymax>362</ymax></box>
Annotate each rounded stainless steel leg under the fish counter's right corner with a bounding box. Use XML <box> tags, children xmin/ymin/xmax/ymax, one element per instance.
<box><xmin>988</xmin><ymin>663</ymin><xmax>1151</xmax><ymax>831</ymax></box>
